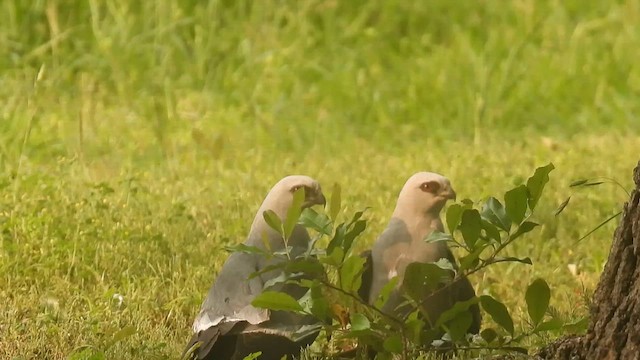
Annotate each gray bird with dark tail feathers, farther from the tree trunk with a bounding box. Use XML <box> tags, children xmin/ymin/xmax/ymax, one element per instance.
<box><xmin>183</xmin><ymin>175</ymin><xmax>326</xmax><ymax>360</ymax></box>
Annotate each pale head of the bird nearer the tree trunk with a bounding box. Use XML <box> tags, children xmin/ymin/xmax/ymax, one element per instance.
<box><xmin>395</xmin><ymin>172</ymin><xmax>456</xmax><ymax>216</ymax></box>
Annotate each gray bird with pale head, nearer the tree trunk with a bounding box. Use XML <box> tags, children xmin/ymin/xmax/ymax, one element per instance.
<box><xmin>368</xmin><ymin>172</ymin><xmax>481</xmax><ymax>333</ymax></box>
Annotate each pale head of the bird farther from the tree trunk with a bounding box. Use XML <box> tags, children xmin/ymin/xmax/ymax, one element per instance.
<box><xmin>256</xmin><ymin>175</ymin><xmax>327</xmax><ymax>219</ymax></box>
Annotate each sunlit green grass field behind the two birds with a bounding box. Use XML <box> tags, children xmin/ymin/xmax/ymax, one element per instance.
<box><xmin>0</xmin><ymin>0</ymin><xmax>640</xmax><ymax>359</ymax></box>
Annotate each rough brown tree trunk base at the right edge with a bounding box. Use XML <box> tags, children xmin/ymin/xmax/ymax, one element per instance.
<box><xmin>538</xmin><ymin>162</ymin><xmax>640</xmax><ymax>360</ymax></box>
